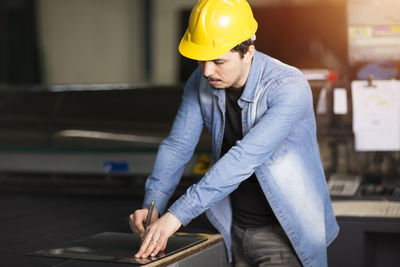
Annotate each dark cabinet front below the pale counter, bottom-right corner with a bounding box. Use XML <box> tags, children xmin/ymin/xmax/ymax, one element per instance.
<box><xmin>328</xmin><ymin>217</ymin><xmax>400</xmax><ymax>267</ymax></box>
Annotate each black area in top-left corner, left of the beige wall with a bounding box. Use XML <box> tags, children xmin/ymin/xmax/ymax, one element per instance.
<box><xmin>0</xmin><ymin>0</ymin><xmax>42</xmax><ymax>84</ymax></box>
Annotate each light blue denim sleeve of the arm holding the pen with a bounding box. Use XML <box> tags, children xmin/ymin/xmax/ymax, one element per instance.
<box><xmin>143</xmin><ymin>69</ymin><xmax>203</xmax><ymax>213</ymax></box>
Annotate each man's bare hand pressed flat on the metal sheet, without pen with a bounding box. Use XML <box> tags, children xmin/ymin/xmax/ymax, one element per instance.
<box><xmin>135</xmin><ymin>212</ymin><xmax>182</xmax><ymax>258</ymax></box>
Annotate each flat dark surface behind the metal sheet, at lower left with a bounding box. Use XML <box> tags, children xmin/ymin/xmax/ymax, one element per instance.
<box><xmin>0</xmin><ymin>189</ymin><xmax>215</xmax><ymax>267</ymax></box>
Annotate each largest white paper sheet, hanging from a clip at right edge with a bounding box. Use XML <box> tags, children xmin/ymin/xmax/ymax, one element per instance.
<box><xmin>351</xmin><ymin>80</ymin><xmax>400</xmax><ymax>151</ymax></box>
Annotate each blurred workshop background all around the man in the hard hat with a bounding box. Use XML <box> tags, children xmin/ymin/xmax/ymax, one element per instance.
<box><xmin>0</xmin><ymin>0</ymin><xmax>400</xmax><ymax>267</ymax></box>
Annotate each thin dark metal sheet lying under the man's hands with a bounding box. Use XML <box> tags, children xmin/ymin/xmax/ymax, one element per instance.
<box><xmin>28</xmin><ymin>232</ymin><xmax>207</xmax><ymax>265</ymax></box>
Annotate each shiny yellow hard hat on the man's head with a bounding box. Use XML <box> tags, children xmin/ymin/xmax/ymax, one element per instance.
<box><xmin>179</xmin><ymin>0</ymin><xmax>257</xmax><ymax>61</ymax></box>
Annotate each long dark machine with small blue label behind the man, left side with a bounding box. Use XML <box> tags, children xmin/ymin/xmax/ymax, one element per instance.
<box><xmin>0</xmin><ymin>84</ymin><xmax>210</xmax><ymax>198</ymax></box>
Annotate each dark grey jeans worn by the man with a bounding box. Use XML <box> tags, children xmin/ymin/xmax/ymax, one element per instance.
<box><xmin>232</xmin><ymin>224</ymin><xmax>302</xmax><ymax>267</ymax></box>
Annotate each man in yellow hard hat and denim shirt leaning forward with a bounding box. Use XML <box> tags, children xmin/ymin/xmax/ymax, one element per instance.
<box><xmin>130</xmin><ymin>0</ymin><xmax>338</xmax><ymax>267</ymax></box>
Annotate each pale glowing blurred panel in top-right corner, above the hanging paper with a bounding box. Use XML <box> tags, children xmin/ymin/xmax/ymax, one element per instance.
<box><xmin>347</xmin><ymin>0</ymin><xmax>400</xmax><ymax>65</ymax></box>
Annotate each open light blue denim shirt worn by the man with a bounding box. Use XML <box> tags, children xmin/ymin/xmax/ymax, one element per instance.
<box><xmin>143</xmin><ymin>51</ymin><xmax>339</xmax><ymax>267</ymax></box>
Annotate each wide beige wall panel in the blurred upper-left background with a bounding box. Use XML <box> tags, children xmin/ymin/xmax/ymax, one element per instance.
<box><xmin>38</xmin><ymin>0</ymin><xmax>145</xmax><ymax>84</ymax></box>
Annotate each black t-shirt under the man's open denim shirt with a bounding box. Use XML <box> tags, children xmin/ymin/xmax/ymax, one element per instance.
<box><xmin>221</xmin><ymin>88</ymin><xmax>277</xmax><ymax>227</ymax></box>
